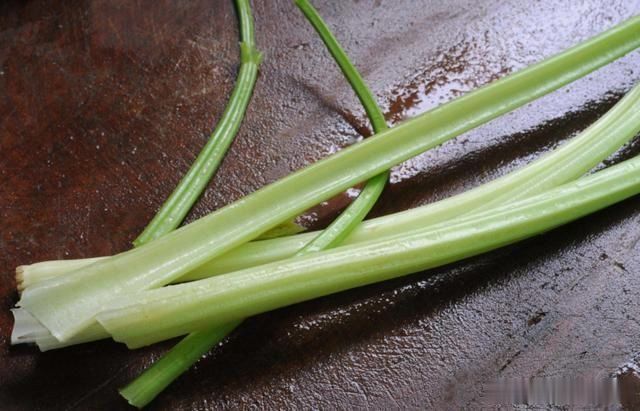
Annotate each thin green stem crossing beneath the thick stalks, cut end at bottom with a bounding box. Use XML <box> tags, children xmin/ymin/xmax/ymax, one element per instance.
<box><xmin>120</xmin><ymin>0</ymin><xmax>396</xmax><ymax>407</ymax></box>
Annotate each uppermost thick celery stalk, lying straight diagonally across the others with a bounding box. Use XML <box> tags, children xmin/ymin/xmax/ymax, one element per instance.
<box><xmin>15</xmin><ymin>17</ymin><xmax>640</xmax><ymax>341</ymax></box>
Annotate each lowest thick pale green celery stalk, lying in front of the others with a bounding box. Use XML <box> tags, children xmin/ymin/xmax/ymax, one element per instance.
<box><xmin>97</xmin><ymin>157</ymin><xmax>640</xmax><ymax>347</ymax></box>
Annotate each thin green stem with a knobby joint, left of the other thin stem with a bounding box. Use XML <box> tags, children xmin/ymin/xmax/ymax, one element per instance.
<box><xmin>133</xmin><ymin>0</ymin><xmax>262</xmax><ymax>246</ymax></box>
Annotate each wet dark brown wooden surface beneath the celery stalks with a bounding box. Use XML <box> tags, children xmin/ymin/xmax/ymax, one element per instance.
<box><xmin>0</xmin><ymin>0</ymin><xmax>640</xmax><ymax>410</ymax></box>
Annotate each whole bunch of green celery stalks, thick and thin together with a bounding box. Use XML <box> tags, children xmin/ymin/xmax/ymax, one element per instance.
<box><xmin>12</xmin><ymin>0</ymin><xmax>640</xmax><ymax>407</ymax></box>
